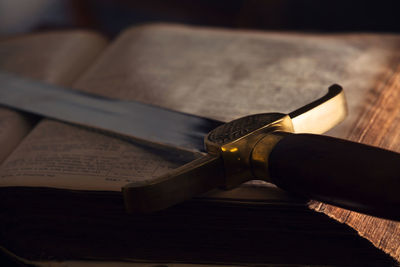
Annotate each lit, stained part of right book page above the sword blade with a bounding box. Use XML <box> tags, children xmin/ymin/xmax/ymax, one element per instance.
<box><xmin>76</xmin><ymin>25</ymin><xmax>400</xmax><ymax>136</ymax></box>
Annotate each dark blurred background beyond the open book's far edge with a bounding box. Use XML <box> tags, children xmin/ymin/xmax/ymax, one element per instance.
<box><xmin>0</xmin><ymin>0</ymin><xmax>400</xmax><ymax>38</ymax></box>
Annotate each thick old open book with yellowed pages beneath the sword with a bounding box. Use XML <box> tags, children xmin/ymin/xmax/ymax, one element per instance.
<box><xmin>0</xmin><ymin>24</ymin><xmax>400</xmax><ymax>265</ymax></box>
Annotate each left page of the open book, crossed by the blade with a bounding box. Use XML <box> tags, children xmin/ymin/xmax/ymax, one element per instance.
<box><xmin>0</xmin><ymin>31</ymin><xmax>106</xmax><ymax>162</ymax></box>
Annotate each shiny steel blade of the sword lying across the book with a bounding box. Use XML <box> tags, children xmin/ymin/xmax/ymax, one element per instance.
<box><xmin>0</xmin><ymin>72</ymin><xmax>222</xmax><ymax>151</ymax></box>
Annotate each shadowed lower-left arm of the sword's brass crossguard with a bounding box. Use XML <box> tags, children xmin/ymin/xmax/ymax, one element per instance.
<box><xmin>122</xmin><ymin>155</ymin><xmax>225</xmax><ymax>213</ymax></box>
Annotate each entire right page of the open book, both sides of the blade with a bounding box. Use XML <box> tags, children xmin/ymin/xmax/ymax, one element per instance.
<box><xmin>0</xmin><ymin>25</ymin><xmax>400</xmax><ymax>191</ymax></box>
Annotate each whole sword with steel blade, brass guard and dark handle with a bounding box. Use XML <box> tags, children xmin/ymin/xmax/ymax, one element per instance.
<box><xmin>0</xmin><ymin>73</ymin><xmax>400</xmax><ymax>220</ymax></box>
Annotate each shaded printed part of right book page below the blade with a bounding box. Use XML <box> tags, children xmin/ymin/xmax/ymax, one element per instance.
<box><xmin>0</xmin><ymin>120</ymin><xmax>186</xmax><ymax>191</ymax></box>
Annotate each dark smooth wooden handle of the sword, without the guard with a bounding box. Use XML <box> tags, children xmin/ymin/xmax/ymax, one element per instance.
<box><xmin>269</xmin><ymin>134</ymin><xmax>400</xmax><ymax>220</ymax></box>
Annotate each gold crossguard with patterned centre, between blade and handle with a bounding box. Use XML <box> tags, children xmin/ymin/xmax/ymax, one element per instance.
<box><xmin>122</xmin><ymin>85</ymin><xmax>347</xmax><ymax>212</ymax></box>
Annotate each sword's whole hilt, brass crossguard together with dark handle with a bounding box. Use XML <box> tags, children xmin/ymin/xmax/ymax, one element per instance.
<box><xmin>123</xmin><ymin>85</ymin><xmax>400</xmax><ymax>220</ymax></box>
